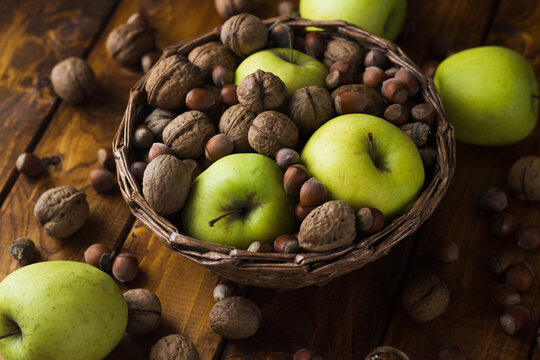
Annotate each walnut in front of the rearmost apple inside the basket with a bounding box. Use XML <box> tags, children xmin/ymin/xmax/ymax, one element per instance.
<box><xmin>236</xmin><ymin>70</ymin><xmax>286</xmax><ymax>114</ymax></box>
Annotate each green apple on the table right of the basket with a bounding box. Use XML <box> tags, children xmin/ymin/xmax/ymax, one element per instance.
<box><xmin>435</xmin><ymin>46</ymin><xmax>538</xmax><ymax>146</ymax></box>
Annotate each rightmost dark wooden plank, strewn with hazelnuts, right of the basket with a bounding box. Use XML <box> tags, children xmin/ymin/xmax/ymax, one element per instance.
<box><xmin>384</xmin><ymin>0</ymin><xmax>540</xmax><ymax>359</ymax></box>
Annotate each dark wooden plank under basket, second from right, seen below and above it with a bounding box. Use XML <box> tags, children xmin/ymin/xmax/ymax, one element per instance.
<box><xmin>224</xmin><ymin>0</ymin><xmax>496</xmax><ymax>360</ymax></box>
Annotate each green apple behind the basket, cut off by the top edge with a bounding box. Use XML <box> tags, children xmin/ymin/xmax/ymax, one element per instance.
<box><xmin>300</xmin><ymin>0</ymin><xmax>407</xmax><ymax>40</ymax></box>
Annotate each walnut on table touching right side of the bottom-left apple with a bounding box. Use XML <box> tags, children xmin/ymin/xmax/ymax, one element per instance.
<box><xmin>124</xmin><ymin>289</ymin><xmax>161</xmax><ymax>336</ymax></box>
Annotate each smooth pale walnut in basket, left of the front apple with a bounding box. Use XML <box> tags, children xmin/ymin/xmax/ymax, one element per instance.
<box><xmin>143</xmin><ymin>155</ymin><xmax>191</xmax><ymax>215</ymax></box>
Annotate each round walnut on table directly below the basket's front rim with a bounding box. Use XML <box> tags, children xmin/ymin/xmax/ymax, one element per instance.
<box><xmin>208</xmin><ymin>296</ymin><xmax>262</xmax><ymax>339</ymax></box>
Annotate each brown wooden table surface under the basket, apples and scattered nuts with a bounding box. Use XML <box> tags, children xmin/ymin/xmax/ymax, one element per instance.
<box><xmin>0</xmin><ymin>0</ymin><xmax>540</xmax><ymax>360</ymax></box>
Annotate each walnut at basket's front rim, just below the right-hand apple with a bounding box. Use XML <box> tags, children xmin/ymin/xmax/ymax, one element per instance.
<box><xmin>298</xmin><ymin>200</ymin><xmax>356</xmax><ymax>252</ymax></box>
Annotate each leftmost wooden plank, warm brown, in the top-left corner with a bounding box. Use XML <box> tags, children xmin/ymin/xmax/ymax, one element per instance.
<box><xmin>0</xmin><ymin>0</ymin><xmax>117</xmax><ymax>201</ymax></box>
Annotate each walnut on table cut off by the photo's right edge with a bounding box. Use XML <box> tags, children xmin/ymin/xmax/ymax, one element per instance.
<box><xmin>508</xmin><ymin>156</ymin><xmax>540</xmax><ymax>201</ymax></box>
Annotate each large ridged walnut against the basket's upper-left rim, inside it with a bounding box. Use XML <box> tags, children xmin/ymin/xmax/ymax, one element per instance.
<box><xmin>145</xmin><ymin>55</ymin><xmax>202</xmax><ymax>109</ymax></box>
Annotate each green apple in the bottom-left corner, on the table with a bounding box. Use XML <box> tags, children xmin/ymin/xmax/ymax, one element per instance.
<box><xmin>0</xmin><ymin>261</ymin><xmax>128</xmax><ymax>360</ymax></box>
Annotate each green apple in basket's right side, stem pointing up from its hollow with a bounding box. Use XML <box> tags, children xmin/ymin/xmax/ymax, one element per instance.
<box><xmin>301</xmin><ymin>114</ymin><xmax>424</xmax><ymax>218</ymax></box>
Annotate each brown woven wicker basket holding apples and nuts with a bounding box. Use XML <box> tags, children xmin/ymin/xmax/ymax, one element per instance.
<box><xmin>113</xmin><ymin>18</ymin><xmax>455</xmax><ymax>290</ymax></box>
